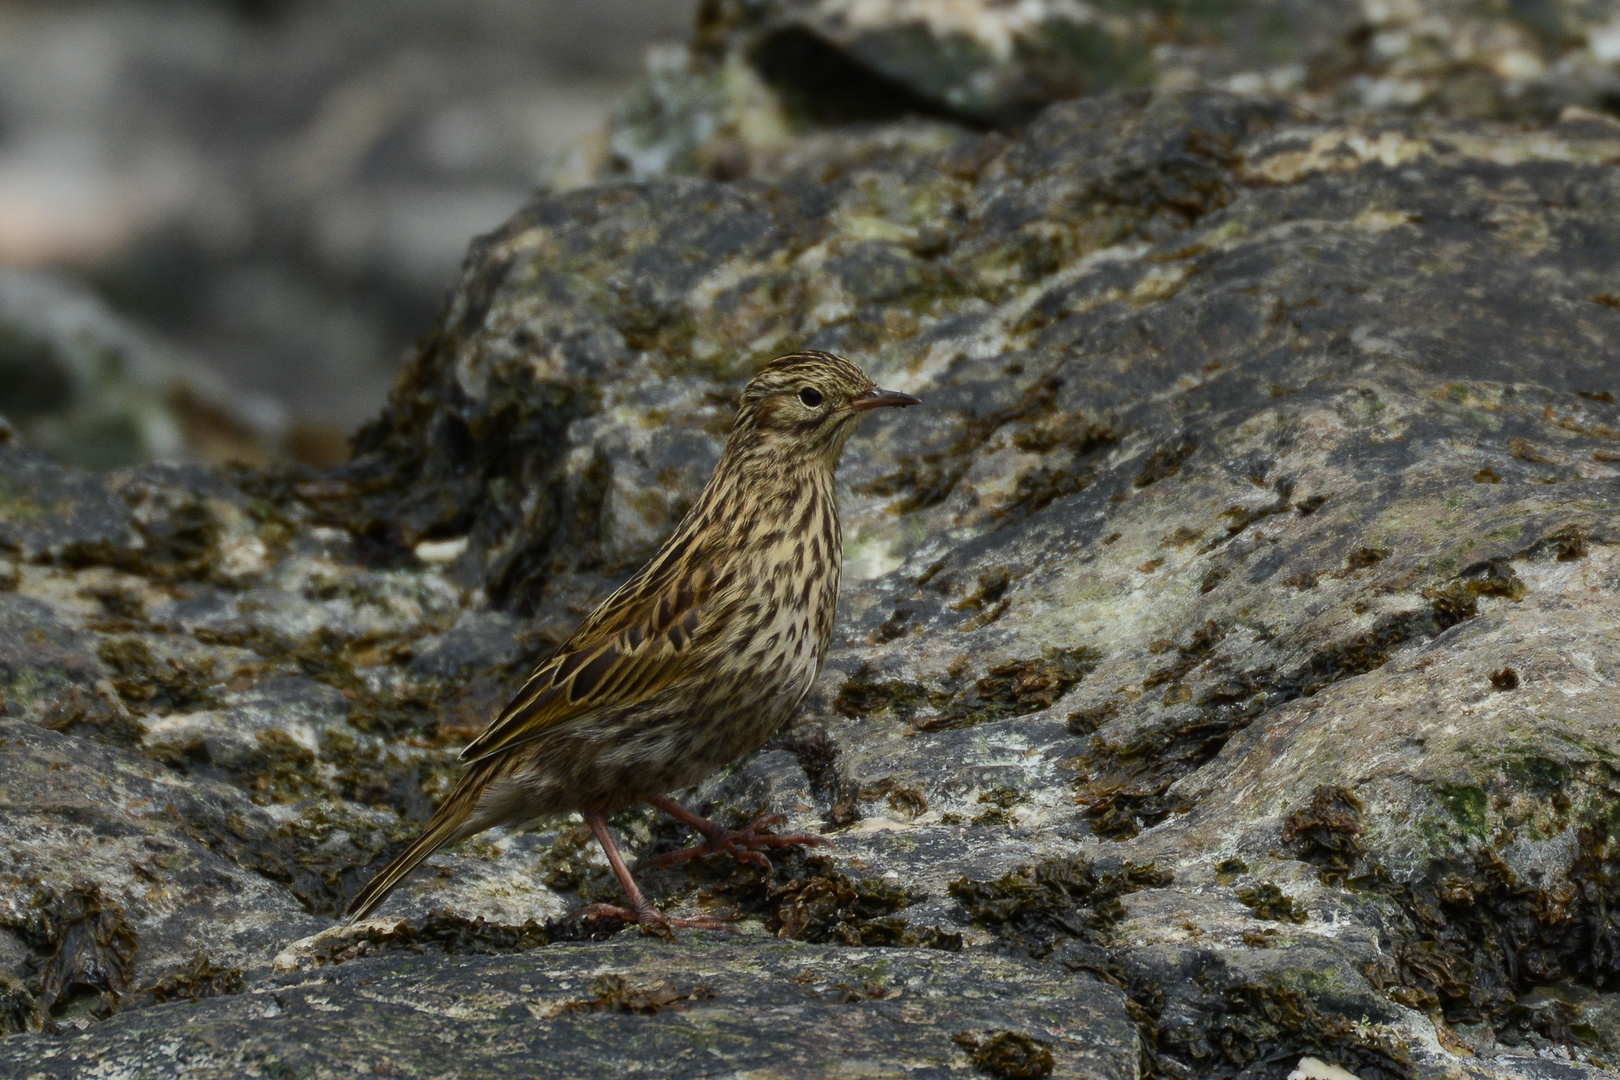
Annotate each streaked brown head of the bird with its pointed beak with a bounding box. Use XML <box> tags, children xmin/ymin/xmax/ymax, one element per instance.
<box><xmin>731</xmin><ymin>353</ymin><xmax>919</xmax><ymax>466</ymax></box>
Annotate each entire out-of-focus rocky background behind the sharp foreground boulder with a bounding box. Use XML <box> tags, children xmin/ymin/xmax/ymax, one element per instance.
<box><xmin>9</xmin><ymin>0</ymin><xmax>1620</xmax><ymax>468</ymax></box>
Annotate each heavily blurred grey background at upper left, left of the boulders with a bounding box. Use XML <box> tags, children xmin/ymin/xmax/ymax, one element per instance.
<box><xmin>0</xmin><ymin>0</ymin><xmax>693</xmax><ymax>466</ymax></box>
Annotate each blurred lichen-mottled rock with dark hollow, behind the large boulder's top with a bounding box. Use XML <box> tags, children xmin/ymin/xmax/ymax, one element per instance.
<box><xmin>589</xmin><ymin>0</ymin><xmax>1620</xmax><ymax>186</ymax></box>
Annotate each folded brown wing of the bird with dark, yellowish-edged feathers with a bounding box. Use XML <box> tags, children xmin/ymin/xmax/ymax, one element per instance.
<box><xmin>462</xmin><ymin>563</ymin><xmax>721</xmax><ymax>761</ymax></box>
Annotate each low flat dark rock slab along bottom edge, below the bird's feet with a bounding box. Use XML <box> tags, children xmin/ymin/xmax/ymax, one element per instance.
<box><xmin>0</xmin><ymin>939</ymin><xmax>1137</xmax><ymax>1080</ymax></box>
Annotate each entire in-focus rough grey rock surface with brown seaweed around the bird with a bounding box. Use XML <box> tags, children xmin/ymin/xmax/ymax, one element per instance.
<box><xmin>0</xmin><ymin>74</ymin><xmax>1620</xmax><ymax>1080</ymax></box>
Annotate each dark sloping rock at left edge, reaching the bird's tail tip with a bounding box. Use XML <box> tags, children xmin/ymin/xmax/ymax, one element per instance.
<box><xmin>0</xmin><ymin>719</ymin><xmax>319</xmax><ymax>1003</ymax></box>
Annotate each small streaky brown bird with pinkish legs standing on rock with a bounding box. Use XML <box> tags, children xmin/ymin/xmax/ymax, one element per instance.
<box><xmin>348</xmin><ymin>353</ymin><xmax>919</xmax><ymax>933</ymax></box>
